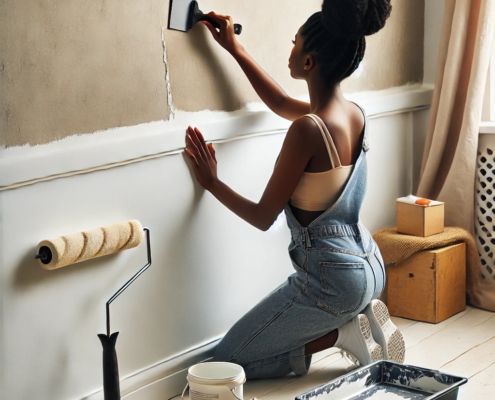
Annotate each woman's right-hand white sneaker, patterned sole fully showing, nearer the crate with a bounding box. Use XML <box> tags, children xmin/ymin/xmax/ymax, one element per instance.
<box><xmin>363</xmin><ymin>300</ymin><xmax>406</xmax><ymax>363</ymax></box>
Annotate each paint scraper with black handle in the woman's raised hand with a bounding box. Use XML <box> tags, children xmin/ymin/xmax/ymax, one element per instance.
<box><xmin>168</xmin><ymin>0</ymin><xmax>242</xmax><ymax>35</ymax></box>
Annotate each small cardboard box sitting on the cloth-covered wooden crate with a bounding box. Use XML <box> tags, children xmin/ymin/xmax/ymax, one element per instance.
<box><xmin>397</xmin><ymin>199</ymin><xmax>445</xmax><ymax>237</ymax></box>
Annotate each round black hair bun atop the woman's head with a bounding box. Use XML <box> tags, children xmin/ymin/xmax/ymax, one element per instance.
<box><xmin>321</xmin><ymin>0</ymin><xmax>392</xmax><ymax>40</ymax></box>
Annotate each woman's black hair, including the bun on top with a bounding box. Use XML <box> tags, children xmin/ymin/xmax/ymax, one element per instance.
<box><xmin>301</xmin><ymin>0</ymin><xmax>392</xmax><ymax>87</ymax></box>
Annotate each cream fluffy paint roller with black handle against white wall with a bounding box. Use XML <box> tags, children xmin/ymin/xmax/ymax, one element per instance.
<box><xmin>36</xmin><ymin>220</ymin><xmax>151</xmax><ymax>400</ymax></box>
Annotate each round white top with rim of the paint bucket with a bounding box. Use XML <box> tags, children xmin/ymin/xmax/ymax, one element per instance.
<box><xmin>187</xmin><ymin>362</ymin><xmax>245</xmax><ymax>385</ymax></box>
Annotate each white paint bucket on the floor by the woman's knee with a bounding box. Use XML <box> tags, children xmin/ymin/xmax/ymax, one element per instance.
<box><xmin>182</xmin><ymin>362</ymin><xmax>246</xmax><ymax>400</ymax></box>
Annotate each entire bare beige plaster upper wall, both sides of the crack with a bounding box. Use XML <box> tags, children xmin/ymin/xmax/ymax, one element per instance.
<box><xmin>0</xmin><ymin>0</ymin><xmax>424</xmax><ymax>147</ymax></box>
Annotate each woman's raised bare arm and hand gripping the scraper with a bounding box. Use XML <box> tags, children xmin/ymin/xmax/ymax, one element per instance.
<box><xmin>202</xmin><ymin>12</ymin><xmax>310</xmax><ymax>121</ymax></box>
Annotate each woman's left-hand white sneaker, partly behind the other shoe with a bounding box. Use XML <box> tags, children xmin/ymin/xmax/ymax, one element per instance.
<box><xmin>334</xmin><ymin>314</ymin><xmax>383</xmax><ymax>366</ymax></box>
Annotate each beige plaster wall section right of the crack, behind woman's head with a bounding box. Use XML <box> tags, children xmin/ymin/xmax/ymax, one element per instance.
<box><xmin>170</xmin><ymin>0</ymin><xmax>425</xmax><ymax>111</ymax></box>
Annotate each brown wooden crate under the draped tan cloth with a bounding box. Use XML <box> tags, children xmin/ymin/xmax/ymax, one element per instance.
<box><xmin>381</xmin><ymin>243</ymin><xmax>466</xmax><ymax>323</ymax></box>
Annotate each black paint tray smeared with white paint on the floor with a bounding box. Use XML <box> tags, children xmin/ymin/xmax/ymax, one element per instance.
<box><xmin>296</xmin><ymin>360</ymin><xmax>467</xmax><ymax>400</ymax></box>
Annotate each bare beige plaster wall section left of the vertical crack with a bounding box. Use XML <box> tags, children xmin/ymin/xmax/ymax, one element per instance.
<box><xmin>0</xmin><ymin>0</ymin><xmax>169</xmax><ymax>146</ymax></box>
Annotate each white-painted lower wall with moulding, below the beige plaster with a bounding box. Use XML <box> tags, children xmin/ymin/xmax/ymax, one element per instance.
<box><xmin>0</xmin><ymin>87</ymin><xmax>431</xmax><ymax>400</ymax></box>
